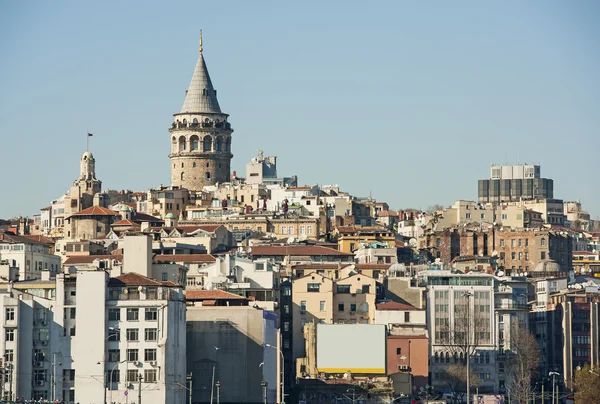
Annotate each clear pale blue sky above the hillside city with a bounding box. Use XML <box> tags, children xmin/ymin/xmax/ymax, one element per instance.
<box><xmin>0</xmin><ymin>0</ymin><xmax>600</xmax><ymax>218</ymax></box>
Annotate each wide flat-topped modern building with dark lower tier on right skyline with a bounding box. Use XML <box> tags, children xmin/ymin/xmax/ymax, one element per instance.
<box><xmin>478</xmin><ymin>164</ymin><xmax>554</xmax><ymax>203</ymax></box>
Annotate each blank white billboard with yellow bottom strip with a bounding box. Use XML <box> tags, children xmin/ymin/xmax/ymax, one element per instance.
<box><xmin>317</xmin><ymin>324</ymin><xmax>386</xmax><ymax>374</ymax></box>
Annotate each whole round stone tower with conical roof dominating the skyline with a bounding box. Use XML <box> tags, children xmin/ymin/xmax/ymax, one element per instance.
<box><xmin>169</xmin><ymin>37</ymin><xmax>233</xmax><ymax>191</ymax></box>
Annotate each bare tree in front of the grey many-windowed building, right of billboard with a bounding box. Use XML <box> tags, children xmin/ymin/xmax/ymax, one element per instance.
<box><xmin>439</xmin><ymin>291</ymin><xmax>491</xmax><ymax>402</ymax></box>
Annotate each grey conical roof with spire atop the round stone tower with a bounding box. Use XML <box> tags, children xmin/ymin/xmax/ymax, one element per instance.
<box><xmin>181</xmin><ymin>38</ymin><xmax>221</xmax><ymax>114</ymax></box>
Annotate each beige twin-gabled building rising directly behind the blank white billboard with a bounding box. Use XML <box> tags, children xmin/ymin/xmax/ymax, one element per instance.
<box><xmin>292</xmin><ymin>273</ymin><xmax>377</xmax><ymax>358</ymax></box>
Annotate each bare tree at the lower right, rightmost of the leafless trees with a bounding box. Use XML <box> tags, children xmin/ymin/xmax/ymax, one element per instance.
<box><xmin>505</xmin><ymin>322</ymin><xmax>540</xmax><ymax>404</ymax></box>
